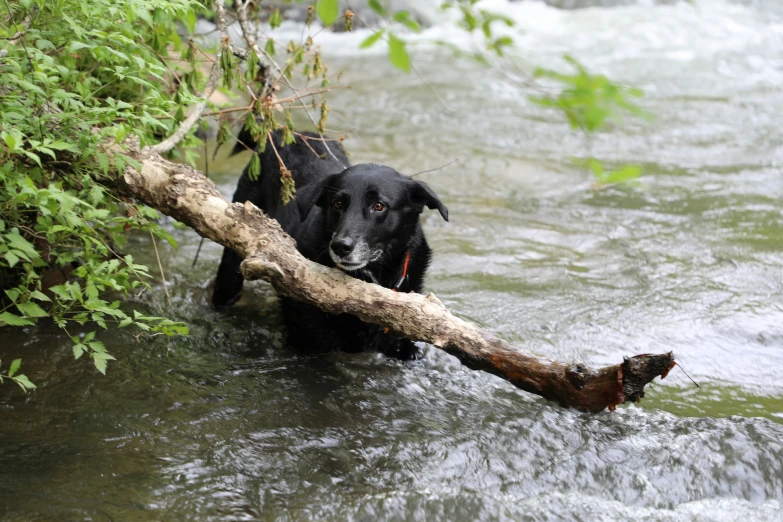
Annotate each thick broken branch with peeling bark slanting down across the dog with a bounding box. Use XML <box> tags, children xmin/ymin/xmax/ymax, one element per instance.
<box><xmin>123</xmin><ymin>137</ymin><xmax>674</xmax><ymax>412</ymax></box>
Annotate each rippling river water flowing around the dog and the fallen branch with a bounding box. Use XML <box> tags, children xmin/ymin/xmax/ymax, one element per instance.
<box><xmin>0</xmin><ymin>0</ymin><xmax>783</xmax><ymax>521</ymax></box>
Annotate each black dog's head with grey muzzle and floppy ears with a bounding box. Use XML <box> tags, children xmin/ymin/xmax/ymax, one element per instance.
<box><xmin>296</xmin><ymin>164</ymin><xmax>449</xmax><ymax>271</ymax></box>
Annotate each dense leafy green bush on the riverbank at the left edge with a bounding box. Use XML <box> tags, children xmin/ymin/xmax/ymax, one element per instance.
<box><xmin>0</xmin><ymin>0</ymin><xmax>194</xmax><ymax>382</ymax></box>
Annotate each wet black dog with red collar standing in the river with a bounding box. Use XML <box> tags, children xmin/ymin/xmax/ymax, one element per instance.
<box><xmin>212</xmin><ymin>133</ymin><xmax>448</xmax><ymax>359</ymax></box>
